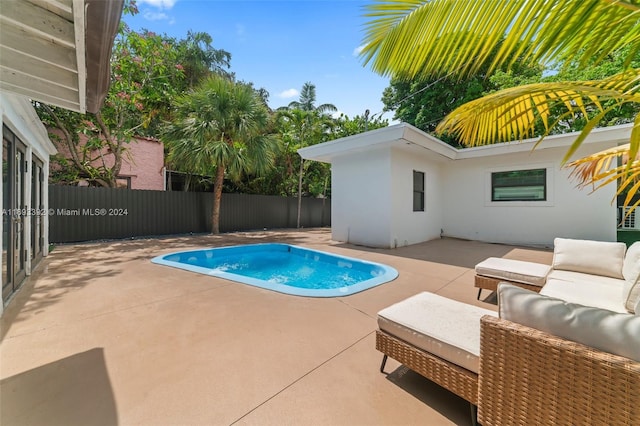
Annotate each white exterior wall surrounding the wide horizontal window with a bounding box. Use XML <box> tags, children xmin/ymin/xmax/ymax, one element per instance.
<box><xmin>442</xmin><ymin>142</ymin><xmax>616</xmax><ymax>246</ymax></box>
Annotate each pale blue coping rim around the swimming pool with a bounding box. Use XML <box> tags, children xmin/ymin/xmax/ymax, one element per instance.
<box><xmin>151</xmin><ymin>243</ymin><xmax>399</xmax><ymax>297</ymax></box>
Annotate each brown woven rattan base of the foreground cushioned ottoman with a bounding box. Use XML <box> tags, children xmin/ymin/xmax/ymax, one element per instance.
<box><xmin>376</xmin><ymin>330</ymin><xmax>478</xmax><ymax>405</ymax></box>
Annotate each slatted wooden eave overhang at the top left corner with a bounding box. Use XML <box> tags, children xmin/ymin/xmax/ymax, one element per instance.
<box><xmin>0</xmin><ymin>0</ymin><xmax>124</xmax><ymax>113</ymax></box>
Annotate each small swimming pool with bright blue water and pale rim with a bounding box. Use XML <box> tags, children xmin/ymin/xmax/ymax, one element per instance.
<box><xmin>151</xmin><ymin>243</ymin><xmax>398</xmax><ymax>297</ymax></box>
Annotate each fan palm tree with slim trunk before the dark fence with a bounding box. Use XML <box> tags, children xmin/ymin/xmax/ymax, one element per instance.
<box><xmin>164</xmin><ymin>75</ymin><xmax>276</xmax><ymax>234</ymax></box>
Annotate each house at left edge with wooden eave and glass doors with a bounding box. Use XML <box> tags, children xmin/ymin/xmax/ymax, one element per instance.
<box><xmin>0</xmin><ymin>0</ymin><xmax>123</xmax><ymax>313</ymax></box>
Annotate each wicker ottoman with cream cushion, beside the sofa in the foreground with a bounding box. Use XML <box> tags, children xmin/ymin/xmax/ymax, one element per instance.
<box><xmin>376</xmin><ymin>292</ymin><xmax>496</xmax><ymax>424</ymax></box>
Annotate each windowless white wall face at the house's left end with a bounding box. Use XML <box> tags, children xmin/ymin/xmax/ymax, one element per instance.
<box><xmin>331</xmin><ymin>149</ymin><xmax>392</xmax><ymax>247</ymax></box>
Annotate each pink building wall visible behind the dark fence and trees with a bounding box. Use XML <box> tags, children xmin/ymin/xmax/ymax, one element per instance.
<box><xmin>52</xmin><ymin>130</ymin><xmax>165</xmax><ymax>191</ymax></box>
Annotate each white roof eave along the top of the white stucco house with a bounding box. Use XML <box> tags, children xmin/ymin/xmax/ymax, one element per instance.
<box><xmin>298</xmin><ymin>123</ymin><xmax>633</xmax><ymax>163</ymax></box>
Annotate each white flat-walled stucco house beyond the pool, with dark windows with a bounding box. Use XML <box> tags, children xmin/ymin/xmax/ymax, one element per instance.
<box><xmin>298</xmin><ymin>123</ymin><xmax>632</xmax><ymax>248</ymax></box>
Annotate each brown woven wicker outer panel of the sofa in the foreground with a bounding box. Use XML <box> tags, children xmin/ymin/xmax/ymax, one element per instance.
<box><xmin>478</xmin><ymin>316</ymin><xmax>640</xmax><ymax>426</ymax></box>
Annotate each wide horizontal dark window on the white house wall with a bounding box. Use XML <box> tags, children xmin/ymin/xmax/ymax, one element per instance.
<box><xmin>491</xmin><ymin>169</ymin><xmax>547</xmax><ymax>201</ymax></box>
